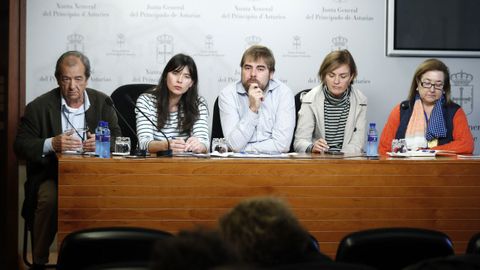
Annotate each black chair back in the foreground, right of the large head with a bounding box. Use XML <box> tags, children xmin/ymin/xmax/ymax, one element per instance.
<box><xmin>336</xmin><ymin>228</ymin><xmax>454</xmax><ymax>270</ymax></box>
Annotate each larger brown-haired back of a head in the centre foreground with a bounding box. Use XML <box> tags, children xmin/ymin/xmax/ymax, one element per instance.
<box><xmin>219</xmin><ymin>197</ymin><xmax>316</xmax><ymax>266</ymax></box>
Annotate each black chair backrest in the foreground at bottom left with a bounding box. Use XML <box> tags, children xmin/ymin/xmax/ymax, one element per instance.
<box><xmin>57</xmin><ymin>227</ymin><xmax>173</xmax><ymax>270</ymax></box>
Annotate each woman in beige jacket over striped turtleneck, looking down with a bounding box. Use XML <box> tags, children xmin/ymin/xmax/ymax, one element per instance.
<box><xmin>294</xmin><ymin>50</ymin><xmax>367</xmax><ymax>154</ymax></box>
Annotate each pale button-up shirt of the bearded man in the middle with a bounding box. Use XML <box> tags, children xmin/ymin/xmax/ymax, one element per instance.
<box><xmin>218</xmin><ymin>79</ymin><xmax>295</xmax><ymax>153</ymax></box>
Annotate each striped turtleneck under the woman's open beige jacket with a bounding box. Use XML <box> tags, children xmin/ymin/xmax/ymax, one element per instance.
<box><xmin>324</xmin><ymin>86</ymin><xmax>350</xmax><ymax>151</ymax></box>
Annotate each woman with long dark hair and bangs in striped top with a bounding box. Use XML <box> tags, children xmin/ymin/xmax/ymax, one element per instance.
<box><xmin>136</xmin><ymin>54</ymin><xmax>209</xmax><ymax>153</ymax></box>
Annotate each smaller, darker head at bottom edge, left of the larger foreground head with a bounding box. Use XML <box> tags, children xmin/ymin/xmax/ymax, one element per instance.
<box><xmin>152</xmin><ymin>229</ymin><xmax>238</xmax><ymax>270</ymax></box>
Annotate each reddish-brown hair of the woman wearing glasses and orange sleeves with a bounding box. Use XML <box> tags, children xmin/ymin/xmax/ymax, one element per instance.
<box><xmin>408</xmin><ymin>58</ymin><xmax>452</xmax><ymax>103</ymax></box>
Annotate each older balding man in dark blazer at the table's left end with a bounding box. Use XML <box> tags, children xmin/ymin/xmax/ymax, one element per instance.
<box><xmin>14</xmin><ymin>51</ymin><xmax>121</xmax><ymax>269</ymax></box>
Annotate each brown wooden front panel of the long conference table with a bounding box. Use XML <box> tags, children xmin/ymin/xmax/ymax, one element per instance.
<box><xmin>58</xmin><ymin>156</ymin><xmax>480</xmax><ymax>258</ymax></box>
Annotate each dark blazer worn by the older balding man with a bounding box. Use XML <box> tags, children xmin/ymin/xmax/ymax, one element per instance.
<box><xmin>14</xmin><ymin>88</ymin><xmax>121</xmax><ymax>226</ymax></box>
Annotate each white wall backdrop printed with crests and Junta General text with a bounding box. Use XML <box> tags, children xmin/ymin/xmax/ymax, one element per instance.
<box><xmin>26</xmin><ymin>0</ymin><xmax>480</xmax><ymax>153</ymax></box>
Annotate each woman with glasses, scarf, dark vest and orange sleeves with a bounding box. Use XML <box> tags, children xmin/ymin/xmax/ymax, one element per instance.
<box><xmin>378</xmin><ymin>59</ymin><xmax>474</xmax><ymax>155</ymax></box>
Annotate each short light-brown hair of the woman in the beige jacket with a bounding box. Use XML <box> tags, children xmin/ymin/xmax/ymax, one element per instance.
<box><xmin>318</xmin><ymin>50</ymin><xmax>358</xmax><ymax>85</ymax></box>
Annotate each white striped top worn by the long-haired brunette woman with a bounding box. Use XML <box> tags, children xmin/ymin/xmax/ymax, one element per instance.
<box><xmin>135</xmin><ymin>93</ymin><xmax>210</xmax><ymax>152</ymax></box>
